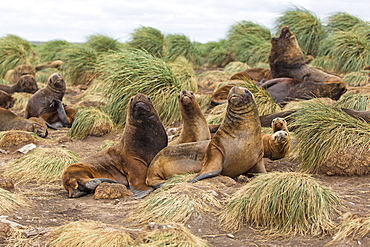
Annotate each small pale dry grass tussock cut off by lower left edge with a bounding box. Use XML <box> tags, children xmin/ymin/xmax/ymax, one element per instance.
<box><xmin>0</xmin><ymin>188</ymin><xmax>28</xmax><ymax>214</ymax></box>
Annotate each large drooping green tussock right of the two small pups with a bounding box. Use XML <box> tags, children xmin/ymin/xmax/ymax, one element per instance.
<box><xmin>290</xmin><ymin>100</ymin><xmax>370</xmax><ymax>173</ymax></box>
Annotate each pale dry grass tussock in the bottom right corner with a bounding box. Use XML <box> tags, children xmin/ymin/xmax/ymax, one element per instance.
<box><xmin>328</xmin><ymin>214</ymin><xmax>370</xmax><ymax>245</ymax></box>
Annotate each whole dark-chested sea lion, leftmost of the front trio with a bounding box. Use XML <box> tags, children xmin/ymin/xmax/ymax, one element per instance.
<box><xmin>62</xmin><ymin>93</ymin><xmax>168</xmax><ymax>198</ymax></box>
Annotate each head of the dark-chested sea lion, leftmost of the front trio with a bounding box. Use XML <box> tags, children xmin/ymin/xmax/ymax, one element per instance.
<box><xmin>127</xmin><ymin>93</ymin><xmax>156</xmax><ymax>121</ymax></box>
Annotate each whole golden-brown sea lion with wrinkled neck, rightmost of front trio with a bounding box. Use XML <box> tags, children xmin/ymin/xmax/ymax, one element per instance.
<box><xmin>146</xmin><ymin>86</ymin><xmax>266</xmax><ymax>188</ymax></box>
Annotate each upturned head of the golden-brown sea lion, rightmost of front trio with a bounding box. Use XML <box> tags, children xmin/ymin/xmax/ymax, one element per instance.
<box><xmin>227</xmin><ymin>86</ymin><xmax>257</xmax><ymax>112</ymax></box>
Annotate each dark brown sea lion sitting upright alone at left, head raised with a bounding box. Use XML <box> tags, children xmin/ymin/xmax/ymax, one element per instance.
<box><xmin>25</xmin><ymin>73</ymin><xmax>76</xmax><ymax>128</ymax></box>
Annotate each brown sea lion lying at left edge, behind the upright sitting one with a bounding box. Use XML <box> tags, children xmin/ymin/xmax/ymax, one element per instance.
<box><xmin>0</xmin><ymin>75</ymin><xmax>39</xmax><ymax>94</ymax></box>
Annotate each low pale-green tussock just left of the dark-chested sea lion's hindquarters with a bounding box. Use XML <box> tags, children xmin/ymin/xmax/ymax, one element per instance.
<box><xmin>4</xmin><ymin>148</ymin><xmax>79</xmax><ymax>183</ymax></box>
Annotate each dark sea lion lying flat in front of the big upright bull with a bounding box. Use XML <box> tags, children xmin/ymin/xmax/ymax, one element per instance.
<box><xmin>260</xmin><ymin>77</ymin><xmax>347</xmax><ymax>106</ymax></box>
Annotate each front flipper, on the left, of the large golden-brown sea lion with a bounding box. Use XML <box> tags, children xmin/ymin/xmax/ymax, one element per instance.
<box><xmin>189</xmin><ymin>143</ymin><xmax>224</xmax><ymax>183</ymax></box>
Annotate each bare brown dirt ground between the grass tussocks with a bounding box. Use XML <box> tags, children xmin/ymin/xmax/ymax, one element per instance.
<box><xmin>0</xmin><ymin>86</ymin><xmax>370</xmax><ymax>247</ymax></box>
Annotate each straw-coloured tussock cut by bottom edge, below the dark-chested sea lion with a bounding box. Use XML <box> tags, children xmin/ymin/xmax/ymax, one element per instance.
<box><xmin>48</xmin><ymin>221</ymin><xmax>134</xmax><ymax>247</ymax></box>
